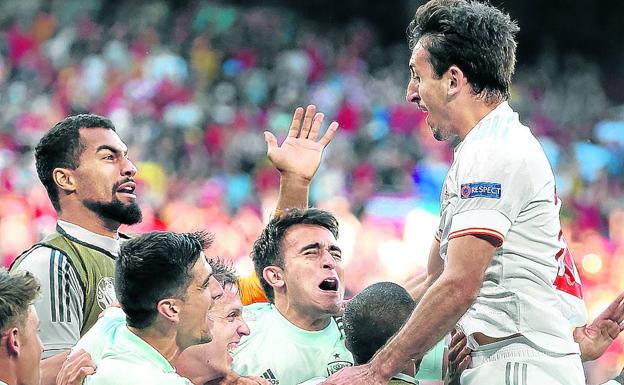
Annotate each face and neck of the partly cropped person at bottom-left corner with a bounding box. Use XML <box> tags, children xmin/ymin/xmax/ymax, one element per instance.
<box><xmin>17</xmin><ymin>305</ymin><xmax>43</xmax><ymax>385</ymax></box>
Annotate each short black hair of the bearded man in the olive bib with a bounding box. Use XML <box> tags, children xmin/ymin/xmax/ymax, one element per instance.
<box><xmin>35</xmin><ymin>114</ymin><xmax>115</xmax><ymax>212</ymax></box>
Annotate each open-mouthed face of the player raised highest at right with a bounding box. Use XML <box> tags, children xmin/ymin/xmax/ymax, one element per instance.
<box><xmin>405</xmin><ymin>42</ymin><xmax>452</xmax><ymax>140</ymax></box>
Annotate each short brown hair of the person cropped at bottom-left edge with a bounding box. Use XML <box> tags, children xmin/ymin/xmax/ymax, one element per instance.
<box><xmin>0</xmin><ymin>268</ymin><xmax>41</xmax><ymax>334</ymax></box>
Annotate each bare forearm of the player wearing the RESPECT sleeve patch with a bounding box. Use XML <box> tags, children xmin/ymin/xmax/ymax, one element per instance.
<box><xmin>372</xmin><ymin>273</ymin><xmax>480</xmax><ymax>379</ymax></box>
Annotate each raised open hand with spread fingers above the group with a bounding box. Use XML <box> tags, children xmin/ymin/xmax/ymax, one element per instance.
<box><xmin>264</xmin><ymin>104</ymin><xmax>338</xmax><ymax>183</ymax></box>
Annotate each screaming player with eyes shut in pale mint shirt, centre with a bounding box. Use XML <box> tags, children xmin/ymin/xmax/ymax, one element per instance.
<box><xmin>232</xmin><ymin>208</ymin><xmax>353</xmax><ymax>385</ymax></box>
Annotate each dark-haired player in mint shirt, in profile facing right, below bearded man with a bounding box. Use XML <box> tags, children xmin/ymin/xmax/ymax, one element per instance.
<box><xmin>85</xmin><ymin>232</ymin><xmax>223</xmax><ymax>385</ymax></box>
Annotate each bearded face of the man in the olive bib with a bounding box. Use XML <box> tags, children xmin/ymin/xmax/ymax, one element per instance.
<box><xmin>74</xmin><ymin>128</ymin><xmax>142</xmax><ymax>225</ymax></box>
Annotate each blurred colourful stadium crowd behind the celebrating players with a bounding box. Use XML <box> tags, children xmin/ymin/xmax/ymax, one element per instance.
<box><xmin>0</xmin><ymin>0</ymin><xmax>624</xmax><ymax>384</ymax></box>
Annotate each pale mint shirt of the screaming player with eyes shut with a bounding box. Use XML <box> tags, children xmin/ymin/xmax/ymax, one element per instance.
<box><xmin>232</xmin><ymin>303</ymin><xmax>353</xmax><ymax>385</ymax></box>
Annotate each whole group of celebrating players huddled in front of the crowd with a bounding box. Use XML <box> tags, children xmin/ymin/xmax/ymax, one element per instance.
<box><xmin>0</xmin><ymin>0</ymin><xmax>624</xmax><ymax>385</ymax></box>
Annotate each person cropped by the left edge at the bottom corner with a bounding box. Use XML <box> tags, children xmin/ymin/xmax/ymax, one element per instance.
<box><xmin>0</xmin><ymin>269</ymin><xmax>43</xmax><ymax>385</ymax></box>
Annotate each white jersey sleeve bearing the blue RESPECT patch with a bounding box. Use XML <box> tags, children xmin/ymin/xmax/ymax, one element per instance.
<box><xmin>448</xmin><ymin>141</ymin><xmax>534</xmax><ymax>246</ymax></box>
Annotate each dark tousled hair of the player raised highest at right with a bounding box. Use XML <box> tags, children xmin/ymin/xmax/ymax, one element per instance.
<box><xmin>407</xmin><ymin>0</ymin><xmax>520</xmax><ymax>101</ymax></box>
